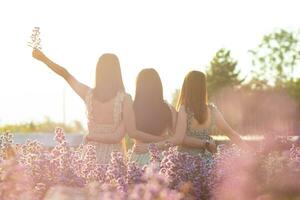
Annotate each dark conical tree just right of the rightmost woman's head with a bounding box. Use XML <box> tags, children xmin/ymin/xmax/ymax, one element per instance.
<box><xmin>207</xmin><ymin>48</ymin><xmax>244</xmax><ymax>97</ymax></box>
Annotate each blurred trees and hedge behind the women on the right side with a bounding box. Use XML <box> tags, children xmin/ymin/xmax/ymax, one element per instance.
<box><xmin>172</xmin><ymin>29</ymin><xmax>300</xmax><ymax>135</ymax></box>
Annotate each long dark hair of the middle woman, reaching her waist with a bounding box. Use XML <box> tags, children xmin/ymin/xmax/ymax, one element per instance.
<box><xmin>133</xmin><ymin>68</ymin><xmax>172</xmax><ymax>135</ymax></box>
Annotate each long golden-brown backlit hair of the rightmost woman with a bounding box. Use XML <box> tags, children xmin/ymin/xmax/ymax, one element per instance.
<box><xmin>177</xmin><ymin>71</ymin><xmax>208</xmax><ymax>124</ymax></box>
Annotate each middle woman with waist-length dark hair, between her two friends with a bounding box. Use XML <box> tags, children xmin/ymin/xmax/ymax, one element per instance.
<box><xmin>131</xmin><ymin>68</ymin><xmax>223</xmax><ymax>165</ymax></box>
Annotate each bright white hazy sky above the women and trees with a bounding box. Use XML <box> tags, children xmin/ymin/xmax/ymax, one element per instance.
<box><xmin>0</xmin><ymin>0</ymin><xmax>300</xmax><ymax>124</ymax></box>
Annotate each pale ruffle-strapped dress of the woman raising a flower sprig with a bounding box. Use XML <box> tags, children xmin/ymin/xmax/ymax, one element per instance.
<box><xmin>85</xmin><ymin>89</ymin><xmax>127</xmax><ymax>164</ymax></box>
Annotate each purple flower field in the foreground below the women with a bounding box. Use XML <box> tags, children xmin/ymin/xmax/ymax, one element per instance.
<box><xmin>0</xmin><ymin>128</ymin><xmax>300</xmax><ymax>200</ymax></box>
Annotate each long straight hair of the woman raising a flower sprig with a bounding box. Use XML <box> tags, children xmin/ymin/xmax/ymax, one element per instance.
<box><xmin>94</xmin><ymin>53</ymin><xmax>125</xmax><ymax>102</ymax></box>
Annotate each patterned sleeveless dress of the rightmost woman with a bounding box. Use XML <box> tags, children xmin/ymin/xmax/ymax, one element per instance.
<box><xmin>179</xmin><ymin>104</ymin><xmax>217</xmax><ymax>157</ymax></box>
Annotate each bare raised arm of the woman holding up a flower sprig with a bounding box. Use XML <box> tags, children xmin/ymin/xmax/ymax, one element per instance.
<box><xmin>32</xmin><ymin>50</ymin><xmax>89</xmax><ymax>100</ymax></box>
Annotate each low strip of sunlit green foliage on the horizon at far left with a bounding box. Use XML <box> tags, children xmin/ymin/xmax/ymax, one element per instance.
<box><xmin>0</xmin><ymin>118</ymin><xmax>84</xmax><ymax>133</ymax></box>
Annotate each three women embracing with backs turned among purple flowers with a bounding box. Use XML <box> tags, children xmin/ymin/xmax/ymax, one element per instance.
<box><xmin>32</xmin><ymin>50</ymin><xmax>243</xmax><ymax>165</ymax></box>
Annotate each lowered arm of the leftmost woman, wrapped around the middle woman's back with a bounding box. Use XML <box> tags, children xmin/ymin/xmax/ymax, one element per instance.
<box><xmin>123</xmin><ymin>96</ymin><xmax>164</xmax><ymax>143</ymax></box>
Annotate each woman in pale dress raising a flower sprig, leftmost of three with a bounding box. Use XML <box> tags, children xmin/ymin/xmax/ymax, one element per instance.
<box><xmin>32</xmin><ymin>49</ymin><xmax>166</xmax><ymax>164</ymax></box>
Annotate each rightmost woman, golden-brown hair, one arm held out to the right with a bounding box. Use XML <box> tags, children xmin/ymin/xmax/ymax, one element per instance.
<box><xmin>136</xmin><ymin>71</ymin><xmax>246</xmax><ymax>155</ymax></box>
